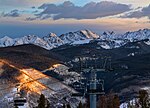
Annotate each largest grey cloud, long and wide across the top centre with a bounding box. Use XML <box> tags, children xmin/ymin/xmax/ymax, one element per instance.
<box><xmin>29</xmin><ymin>1</ymin><xmax>130</xmax><ymax>20</ymax></box>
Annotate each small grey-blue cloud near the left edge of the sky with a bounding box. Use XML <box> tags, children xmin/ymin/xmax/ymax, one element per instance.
<box><xmin>1</xmin><ymin>9</ymin><xmax>20</xmax><ymax>17</ymax></box>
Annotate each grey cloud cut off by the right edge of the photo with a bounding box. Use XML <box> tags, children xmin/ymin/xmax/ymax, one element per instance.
<box><xmin>123</xmin><ymin>5</ymin><xmax>150</xmax><ymax>19</ymax></box>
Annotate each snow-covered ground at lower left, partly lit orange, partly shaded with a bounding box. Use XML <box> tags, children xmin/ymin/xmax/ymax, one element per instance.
<box><xmin>0</xmin><ymin>61</ymin><xmax>80</xmax><ymax>108</ymax></box>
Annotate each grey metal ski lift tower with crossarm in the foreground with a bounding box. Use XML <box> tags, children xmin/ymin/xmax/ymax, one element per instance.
<box><xmin>79</xmin><ymin>56</ymin><xmax>107</xmax><ymax>108</ymax></box>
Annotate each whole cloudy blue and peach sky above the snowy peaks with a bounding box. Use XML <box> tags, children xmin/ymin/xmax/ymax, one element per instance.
<box><xmin>0</xmin><ymin>0</ymin><xmax>150</xmax><ymax>38</ymax></box>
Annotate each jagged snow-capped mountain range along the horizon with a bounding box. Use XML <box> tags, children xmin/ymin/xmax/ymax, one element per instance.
<box><xmin>0</xmin><ymin>29</ymin><xmax>150</xmax><ymax>50</ymax></box>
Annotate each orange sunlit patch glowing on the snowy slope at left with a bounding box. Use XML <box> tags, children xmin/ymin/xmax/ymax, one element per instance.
<box><xmin>0</xmin><ymin>59</ymin><xmax>47</xmax><ymax>94</ymax></box>
